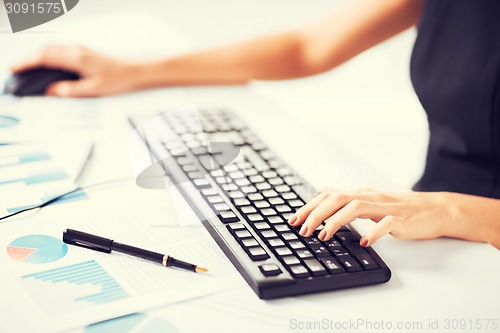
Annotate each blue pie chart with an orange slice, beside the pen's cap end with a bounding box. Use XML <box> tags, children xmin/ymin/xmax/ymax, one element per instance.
<box><xmin>7</xmin><ymin>235</ymin><xmax>68</xmax><ymax>264</ymax></box>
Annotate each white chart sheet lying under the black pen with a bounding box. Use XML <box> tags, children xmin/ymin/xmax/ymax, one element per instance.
<box><xmin>0</xmin><ymin>202</ymin><xmax>245</xmax><ymax>332</ymax></box>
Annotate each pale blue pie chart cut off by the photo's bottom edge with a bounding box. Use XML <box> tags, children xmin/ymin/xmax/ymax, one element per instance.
<box><xmin>85</xmin><ymin>313</ymin><xmax>178</xmax><ymax>333</ymax></box>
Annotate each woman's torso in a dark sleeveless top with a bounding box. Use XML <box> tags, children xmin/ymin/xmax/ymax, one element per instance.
<box><xmin>411</xmin><ymin>0</ymin><xmax>500</xmax><ymax>198</ymax></box>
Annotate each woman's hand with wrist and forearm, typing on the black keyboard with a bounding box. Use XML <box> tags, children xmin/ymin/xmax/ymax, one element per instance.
<box><xmin>289</xmin><ymin>190</ymin><xmax>500</xmax><ymax>248</ymax></box>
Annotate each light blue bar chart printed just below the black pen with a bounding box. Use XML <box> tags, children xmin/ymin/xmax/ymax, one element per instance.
<box><xmin>21</xmin><ymin>260</ymin><xmax>129</xmax><ymax>304</ymax></box>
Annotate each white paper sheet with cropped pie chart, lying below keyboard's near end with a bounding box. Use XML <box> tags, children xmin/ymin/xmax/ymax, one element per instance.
<box><xmin>71</xmin><ymin>286</ymin><xmax>327</xmax><ymax>333</ymax></box>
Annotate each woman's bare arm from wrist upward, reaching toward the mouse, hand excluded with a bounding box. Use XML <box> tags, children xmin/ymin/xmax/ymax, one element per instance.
<box><xmin>129</xmin><ymin>0</ymin><xmax>422</xmax><ymax>88</ymax></box>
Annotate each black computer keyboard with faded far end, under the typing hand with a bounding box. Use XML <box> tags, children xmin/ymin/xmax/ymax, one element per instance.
<box><xmin>133</xmin><ymin>110</ymin><xmax>391</xmax><ymax>299</ymax></box>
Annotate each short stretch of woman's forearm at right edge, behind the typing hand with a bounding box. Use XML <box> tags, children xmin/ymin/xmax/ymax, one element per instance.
<box><xmin>442</xmin><ymin>193</ymin><xmax>500</xmax><ymax>249</ymax></box>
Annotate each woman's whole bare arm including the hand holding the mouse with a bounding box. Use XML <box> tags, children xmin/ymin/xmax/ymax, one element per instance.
<box><xmin>13</xmin><ymin>0</ymin><xmax>423</xmax><ymax>97</ymax></box>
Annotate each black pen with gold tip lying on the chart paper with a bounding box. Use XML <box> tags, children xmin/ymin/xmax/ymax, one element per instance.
<box><xmin>63</xmin><ymin>229</ymin><xmax>208</xmax><ymax>272</ymax></box>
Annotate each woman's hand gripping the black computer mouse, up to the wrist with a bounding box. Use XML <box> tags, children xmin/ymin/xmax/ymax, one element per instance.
<box><xmin>11</xmin><ymin>45</ymin><xmax>140</xmax><ymax>97</ymax></box>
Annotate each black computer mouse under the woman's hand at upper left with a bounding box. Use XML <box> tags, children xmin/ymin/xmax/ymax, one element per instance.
<box><xmin>5</xmin><ymin>67</ymin><xmax>80</xmax><ymax>97</ymax></box>
